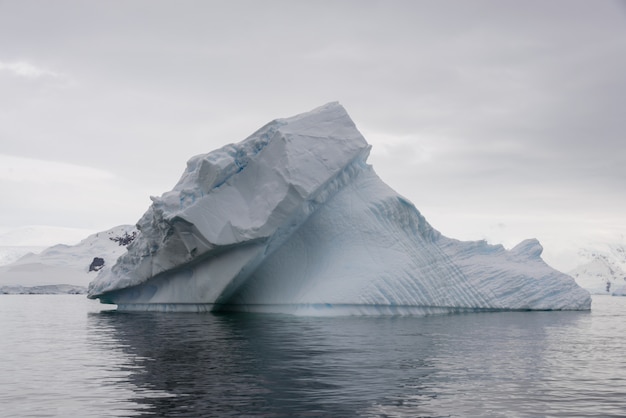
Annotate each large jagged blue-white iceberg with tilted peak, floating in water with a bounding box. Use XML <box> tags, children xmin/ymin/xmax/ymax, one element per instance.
<box><xmin>89</xmin><ymin>103</ymin><xmax>591</xmax><ymax>315</ymax></box>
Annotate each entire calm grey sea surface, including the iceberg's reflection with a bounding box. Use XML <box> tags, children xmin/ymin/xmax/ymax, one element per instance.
<box><xmin>0</xmin><ymin>295</ymin><xmax>626</xmax><ymax>417</ymax></box>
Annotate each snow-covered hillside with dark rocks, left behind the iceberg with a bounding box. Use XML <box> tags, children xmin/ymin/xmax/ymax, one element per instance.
<box><xmin>0</xmin><ymin>225</ymin><xmax>135</xmax><ymax>294</ymax></box>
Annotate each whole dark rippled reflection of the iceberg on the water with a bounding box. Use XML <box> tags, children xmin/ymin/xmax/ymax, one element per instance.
<box><xmin>89</xmin><ymin>312</ymin><xmax>587</xmax><ymax>417</ymax></box>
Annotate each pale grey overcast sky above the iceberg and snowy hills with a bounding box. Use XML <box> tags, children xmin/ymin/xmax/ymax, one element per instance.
<box><xmin>0</xmin><ymin>0</ymin><xmax>626</xmax><ymax>268</ymax></box>
